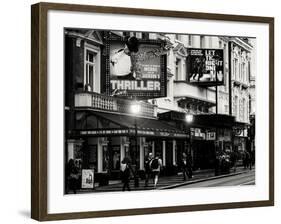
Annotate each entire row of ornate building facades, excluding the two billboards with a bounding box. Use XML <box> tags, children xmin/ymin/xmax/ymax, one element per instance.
<box><xmin>65</xmin><ymin>29</ymin><xmax>255</xmax><ymax>189</ymax></box>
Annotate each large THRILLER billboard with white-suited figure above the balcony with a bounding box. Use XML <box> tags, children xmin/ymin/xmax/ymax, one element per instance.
<box><xmin>106</xmin><ymin>37</ymin><xmax>166</xmax><ymax>99</ymax></box>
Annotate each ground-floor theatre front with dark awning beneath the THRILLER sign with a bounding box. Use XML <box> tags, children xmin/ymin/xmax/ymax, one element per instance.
<box><xmin>67</xmin><ymin>110</ymin><xmax>189</xmax><ymax>183</ymax></box>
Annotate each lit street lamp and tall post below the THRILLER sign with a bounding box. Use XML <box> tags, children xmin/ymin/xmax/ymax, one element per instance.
<box><xmin>130</xmin><ymin>102</ymin><xmax>141</xmax><ymax>187</ymax></box>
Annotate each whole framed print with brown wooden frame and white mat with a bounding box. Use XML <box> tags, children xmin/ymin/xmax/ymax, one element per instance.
<box><xmin>31</xmin><ymin>3</ymin><xmax>274</xmax><ymax>221</ymax></box>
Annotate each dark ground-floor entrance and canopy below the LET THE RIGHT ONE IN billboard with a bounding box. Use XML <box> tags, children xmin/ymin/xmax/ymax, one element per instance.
<box><xmin>160</xmin><ymin>111</ymin><xmax>241</xmax><ymax>170</ymax></box>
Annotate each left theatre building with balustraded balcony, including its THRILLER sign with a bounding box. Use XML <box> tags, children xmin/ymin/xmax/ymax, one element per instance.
<box><xmin>65</xmin><ymin>29</ymin><xmax>189</xmax><ymax>181</ymax></box>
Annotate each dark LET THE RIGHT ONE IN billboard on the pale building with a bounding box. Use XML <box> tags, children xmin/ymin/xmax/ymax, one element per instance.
<box><xmin>187</xmin><ymin>48</ymin><xmax>224</xmax><ymax>86</ymax></box>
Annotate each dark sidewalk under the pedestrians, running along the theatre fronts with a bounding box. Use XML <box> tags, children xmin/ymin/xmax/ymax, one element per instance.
<box><xmin>77</xmin><ymin>167</ymin><xmax>254</xmax><ymax>194</ymax></box>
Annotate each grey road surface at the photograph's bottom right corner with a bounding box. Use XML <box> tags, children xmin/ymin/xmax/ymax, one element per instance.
<box><xmin>178</xmin><ymin>170</ymin><xmax>255</xmax><ymax>188</ymax></box>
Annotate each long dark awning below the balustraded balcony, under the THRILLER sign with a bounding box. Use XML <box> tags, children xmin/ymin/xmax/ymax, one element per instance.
<box><xmin>76</xmin><ymin>111</ymin><xmax>189</xmax><ymax>138</ymax></box>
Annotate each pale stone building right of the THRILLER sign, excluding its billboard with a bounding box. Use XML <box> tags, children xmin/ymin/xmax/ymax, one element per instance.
<box><xmin>154</xmin><ymin>34</ymin><xmax>255</xmax><ymax>166</ymax></box>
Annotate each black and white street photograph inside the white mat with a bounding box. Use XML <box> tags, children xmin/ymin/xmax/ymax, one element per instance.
<box><xmin>62</xmin><ymin>28</ymin><xmax>256</xmax><ymax>194</ymax></box>
